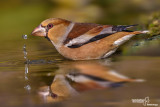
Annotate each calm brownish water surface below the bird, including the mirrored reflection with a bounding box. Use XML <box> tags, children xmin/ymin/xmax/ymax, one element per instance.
<box><xmin>0</xmin><ymin>36</ymin><xmax>160</xmax><ymax>107</ymax></box>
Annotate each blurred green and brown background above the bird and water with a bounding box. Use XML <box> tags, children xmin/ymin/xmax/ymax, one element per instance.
<box><xmin>0</xmin><ymin>0</ymin><xmax>160</xmax><ymax>53</ymax></box>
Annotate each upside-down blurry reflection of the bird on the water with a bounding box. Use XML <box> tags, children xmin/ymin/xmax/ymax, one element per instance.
<box><xmin>39</xmin><ymin>60</ymin><xmax>141</xmax><ymax>102</ymax></box>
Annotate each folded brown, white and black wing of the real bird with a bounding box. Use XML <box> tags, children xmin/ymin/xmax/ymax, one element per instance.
<box><xmin>64</xmin><ymin>23</ymin><xmax>135</xmax><ymax>48</ymax></box>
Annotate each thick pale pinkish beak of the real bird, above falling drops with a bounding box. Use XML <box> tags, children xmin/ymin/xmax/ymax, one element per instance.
<box><xmin>31</xmin><ymin>25</ymin><xmax>46</xmax><ymax>36</ymax></box>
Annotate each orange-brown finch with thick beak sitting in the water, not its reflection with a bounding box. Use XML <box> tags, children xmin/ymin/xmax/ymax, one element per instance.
<box><xmin>31</xmin><ymin>18</ymin><xmax>148</xmax><ymax>60</ymax></box>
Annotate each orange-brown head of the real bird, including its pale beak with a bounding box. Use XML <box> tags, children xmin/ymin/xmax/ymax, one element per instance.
<box><xmin>32</xmin><ymin>18</ymin><xmax>71</xmax><ymax>44</ymax></box>
